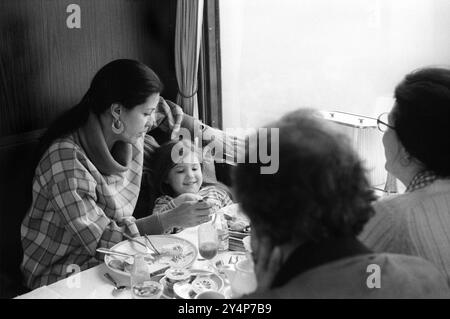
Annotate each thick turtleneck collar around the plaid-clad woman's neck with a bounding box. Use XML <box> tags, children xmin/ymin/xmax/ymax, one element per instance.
<box><xmin>77</xmin><ymin>113</ymin><xmax>132</xmax><ymax>175</ymax></box>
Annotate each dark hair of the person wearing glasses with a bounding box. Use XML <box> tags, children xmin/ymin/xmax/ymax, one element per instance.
<box><xmin>392</xmin><ymin>68</ymin><xmax>450</xmax><ymax>177</ymax></box>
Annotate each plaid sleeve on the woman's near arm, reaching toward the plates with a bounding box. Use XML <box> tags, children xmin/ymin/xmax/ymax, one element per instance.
<box><xmin>51</xmin><ymin>178</ymin><xmax>139</xmax><ymax>257</ymax></box>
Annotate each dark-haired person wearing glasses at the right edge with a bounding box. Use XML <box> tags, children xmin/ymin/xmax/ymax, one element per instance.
<box><xmin>359</xmin><ymin>68</ymin><xmax>450</xmax><ymax>279</ymax></box>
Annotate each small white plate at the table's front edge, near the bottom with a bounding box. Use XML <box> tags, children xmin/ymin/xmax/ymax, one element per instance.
<box><xmin>173</xmin><ymin>269</ymin><xmax>224</xmax><ymax>299</ymax></box>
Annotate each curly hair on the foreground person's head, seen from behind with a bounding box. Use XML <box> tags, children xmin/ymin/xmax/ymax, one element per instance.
<box><xmin>233</xmin><ymin>109</ymin><xmax>375</xmax><ymax>244</ymax></box>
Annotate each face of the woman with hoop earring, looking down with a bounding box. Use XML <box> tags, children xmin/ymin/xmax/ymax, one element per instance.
<box><xmin>120</xmin><ymin>93</ymin><xmax>159</xmax><ymax>144</ymax></box>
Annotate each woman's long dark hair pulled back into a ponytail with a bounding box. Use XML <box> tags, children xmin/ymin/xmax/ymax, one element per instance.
<box><xmin>34</xmin><ymin>59</ymin><xmax>163</xmax><ymax>171</ymax></box>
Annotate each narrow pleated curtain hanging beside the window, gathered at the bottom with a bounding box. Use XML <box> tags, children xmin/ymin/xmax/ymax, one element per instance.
<box><xmin>175</xmin><ymin>0</ymin><xmax>204</xmax><ymax>115</ymax></box>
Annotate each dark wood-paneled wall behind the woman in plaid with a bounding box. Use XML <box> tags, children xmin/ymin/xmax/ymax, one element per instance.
<box><xmin>0</xmin><ymin>0</ymin><xmax>177</xmax><ymax>296</ymax></box>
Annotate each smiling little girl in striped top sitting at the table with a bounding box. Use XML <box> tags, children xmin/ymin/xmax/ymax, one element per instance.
<box><xmin>152</xmin><ymin>140</ymin><xmax>233</xmax><ymax>232</ymax></box>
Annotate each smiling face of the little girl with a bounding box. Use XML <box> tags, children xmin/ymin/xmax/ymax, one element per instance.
<box><xmin>166</xmin><ymin>152</ymin><xmax>203</xmax><ymax>196</ymax></box>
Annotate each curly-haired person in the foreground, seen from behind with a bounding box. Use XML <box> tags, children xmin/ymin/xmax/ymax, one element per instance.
<box><xmin>233</xmin><ymin>109</ymin><xmax>448</xmax><ymax>298</ymax></box>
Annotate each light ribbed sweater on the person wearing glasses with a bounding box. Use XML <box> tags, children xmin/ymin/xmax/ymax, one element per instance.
<box><xmin>359</xmin><ymin>179</ymin><xmax>450</xmax><ymax>281</ymax></box>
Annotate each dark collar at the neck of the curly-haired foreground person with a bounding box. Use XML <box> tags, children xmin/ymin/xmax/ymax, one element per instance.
<box><xmin>272</xmin><ymin>237</ymin><xmax>372</xmax><ymax>288</ymax></box>
